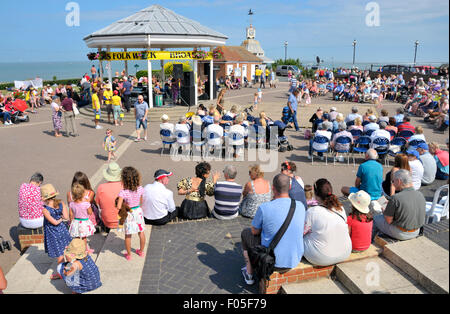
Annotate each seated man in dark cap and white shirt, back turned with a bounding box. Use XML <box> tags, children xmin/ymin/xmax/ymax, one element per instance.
<box><xmin>142</xmin><ymin>170</ymin><xmax>178</xmax><ymax>226</ymax></box>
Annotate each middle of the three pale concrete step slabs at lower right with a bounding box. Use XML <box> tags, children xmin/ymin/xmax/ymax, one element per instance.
<box><xmin>335</xmin><ymin>257</ymin><xmax>427</xmax><ymax>294</ymax></box>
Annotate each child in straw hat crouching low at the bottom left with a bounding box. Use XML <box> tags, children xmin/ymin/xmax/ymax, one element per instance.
<box><xmin>58</xmin><ymin>239</ymin><xmax>102</xmax><ymax>294</ymax></box>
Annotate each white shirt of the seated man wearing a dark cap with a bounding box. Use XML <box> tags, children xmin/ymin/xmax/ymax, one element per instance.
<box><xmin>141</xmin><ymin>182</ymin><xmax>176</xmax><ymax>220</ymax></box>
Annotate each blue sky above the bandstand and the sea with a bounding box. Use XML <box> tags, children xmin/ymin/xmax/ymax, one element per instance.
<box><xmin>0</xmin><ymin>0</ymin><xmax>449</xmax><ymax>63</ymax></box>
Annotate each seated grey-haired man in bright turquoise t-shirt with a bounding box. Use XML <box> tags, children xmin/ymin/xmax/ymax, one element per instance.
<box><xmin>342</xmin><ymin>149</ymin><xmax>383</xmax><ymax>201</ymax></box>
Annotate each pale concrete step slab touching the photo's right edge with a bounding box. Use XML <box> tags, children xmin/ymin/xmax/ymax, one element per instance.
<box><xmin>383</xmin><ymin>237</ymin><xmax>449</xmax><ymax>294</ymax></box>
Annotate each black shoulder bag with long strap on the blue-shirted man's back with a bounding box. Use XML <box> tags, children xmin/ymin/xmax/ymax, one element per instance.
<box><xmin>248</xmin><ymin>199</ymin><xmax>296</xmax><ymax>281</ymax></box>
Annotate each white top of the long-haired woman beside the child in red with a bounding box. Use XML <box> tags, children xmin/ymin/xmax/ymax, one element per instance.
<box><xmin>303</xmin><ymin>206</ymin><xmax>352</xmax><ymax>266</ymax></box>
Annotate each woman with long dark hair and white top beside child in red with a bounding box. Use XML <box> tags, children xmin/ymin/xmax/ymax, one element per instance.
<box><xmin>303</xmin><ymin>179</ymin><xmax>352</xmax><ymax>266</ymax></box>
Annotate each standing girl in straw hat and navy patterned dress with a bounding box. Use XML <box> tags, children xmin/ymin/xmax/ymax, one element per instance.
<box><xmin>41</xmin><ymin>184</ymin><xmax>72</xmax><ymax>280</ymax></box>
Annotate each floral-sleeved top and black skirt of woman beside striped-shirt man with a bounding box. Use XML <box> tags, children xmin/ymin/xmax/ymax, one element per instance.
<box><xmin>177</xmin><ymin>178</ymin><xmax>214</xmax><ymax>220</ymax></box>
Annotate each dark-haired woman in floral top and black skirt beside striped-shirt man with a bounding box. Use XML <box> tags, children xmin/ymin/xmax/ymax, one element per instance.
<box><xmin>178</xmin><ymin>162</ymin><xmax>220</xmax><ymax>220</ymax></box>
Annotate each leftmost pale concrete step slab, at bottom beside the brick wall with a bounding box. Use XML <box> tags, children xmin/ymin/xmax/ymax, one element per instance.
<box><xmin>280</xmin><ymin>278</ymin><xmax>349</xmax><ymax>294</ymax></box>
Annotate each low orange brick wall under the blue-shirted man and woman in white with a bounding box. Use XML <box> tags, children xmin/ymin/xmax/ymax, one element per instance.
<box><xmin>259</xmin><ymin>244</ymin><xmax>383</xmax><ymax>294</ymax></box>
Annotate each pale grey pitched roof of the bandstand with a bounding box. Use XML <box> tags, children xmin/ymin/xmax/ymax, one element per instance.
<box><xmin>84</xmin><ymin>5</ymin><xmax>228</xmax><ymax>48</ymax></box>
